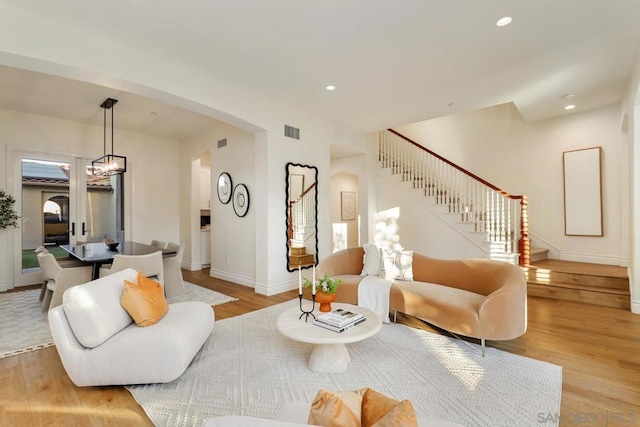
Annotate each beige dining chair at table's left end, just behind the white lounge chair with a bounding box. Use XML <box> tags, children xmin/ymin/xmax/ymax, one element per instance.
<box><xmin>37</xmin><ymin>252</ymin><xmax>92</xmax><ymax>311</ymax></box>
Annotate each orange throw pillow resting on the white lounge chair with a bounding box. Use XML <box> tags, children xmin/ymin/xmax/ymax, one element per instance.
<box><xmin>120</xmin><ymin>272</ymin><xmax>169</xmax><ymax>327</ymax></box>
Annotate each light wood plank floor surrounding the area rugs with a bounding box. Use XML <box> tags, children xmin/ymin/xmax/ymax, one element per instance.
<box><xmin>0</xmin><ymin>271</ymin><xmax>640</xmax><ymax>426</ymax></box>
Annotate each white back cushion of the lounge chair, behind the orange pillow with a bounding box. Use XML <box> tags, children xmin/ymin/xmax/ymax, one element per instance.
<box><xmin>62</xmin><ymin>268</ymin><xmax>138</xmax><ymax>348</ymax></box>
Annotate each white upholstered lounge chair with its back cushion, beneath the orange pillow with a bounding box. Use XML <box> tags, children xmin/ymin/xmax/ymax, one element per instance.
<box><xmin>49</xmin><ymin>269</ymin><xmax>215</xmax><ymax>386</ymax></box>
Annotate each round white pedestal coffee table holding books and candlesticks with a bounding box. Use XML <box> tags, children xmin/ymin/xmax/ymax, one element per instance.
<box><xmin>277</xmin><ymin>303</ymin><xmax>382</xmax><ymax>373</ymax></box>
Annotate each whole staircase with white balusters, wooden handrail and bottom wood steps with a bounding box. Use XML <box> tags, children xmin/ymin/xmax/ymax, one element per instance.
<box><xmin>378</xmin><ymin>129</ymin><xmax>631</xmax><ymax>309</ymax></box>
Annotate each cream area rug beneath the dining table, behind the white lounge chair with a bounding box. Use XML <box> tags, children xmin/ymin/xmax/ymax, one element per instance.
<box><xmin>0</xmin><ymin>282</ymin><xmax>236</xmax><ymax>359</ymax></box>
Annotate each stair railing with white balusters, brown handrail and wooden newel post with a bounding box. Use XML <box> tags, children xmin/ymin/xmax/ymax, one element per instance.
<box><xmin>378</xmin><ymin>129</ymin><xmax>530</xmax><ymax>265</ymax></box>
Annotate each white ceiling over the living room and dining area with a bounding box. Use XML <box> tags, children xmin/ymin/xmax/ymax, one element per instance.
<box><xmin>0</xmin><ymin>0</ymin><xmax>640</xmax><ymax>139</ymax></box>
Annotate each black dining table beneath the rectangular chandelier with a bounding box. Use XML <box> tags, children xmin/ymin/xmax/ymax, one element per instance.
<box><xmin>60</xmin><ymin>241</ymin><xmax>176</xmax><ymax>280</ymax></box>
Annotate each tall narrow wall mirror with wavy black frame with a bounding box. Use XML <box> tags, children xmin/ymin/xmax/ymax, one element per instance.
<box><xmin>285</xmin><ymin>163</ymin><xmax>318</xmax><ymax>271</ymax></box>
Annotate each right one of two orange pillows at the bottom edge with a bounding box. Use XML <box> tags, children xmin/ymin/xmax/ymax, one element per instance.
<box><xmin>362</xmin><ymin>388</ymin><xmax>418</xmax><ymax>427</ymax></box>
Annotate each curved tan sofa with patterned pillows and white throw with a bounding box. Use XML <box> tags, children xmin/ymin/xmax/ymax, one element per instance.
<box><xmin>316</xmin><ymin>247</ymin><xmax>527</xmax><ymax>353</ymax></box>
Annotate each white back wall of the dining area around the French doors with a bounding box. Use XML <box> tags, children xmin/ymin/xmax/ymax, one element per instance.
<box><xmin>0</xmin><ymin>109</ymin><xmax>179</xmax><ymax>288</ymax></box>
